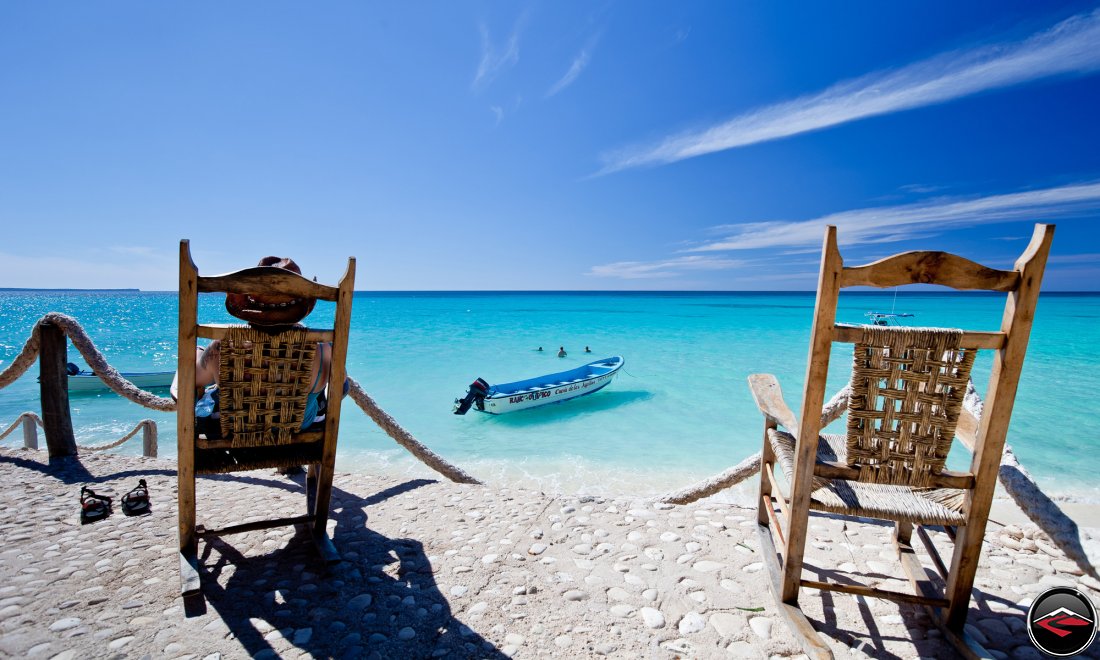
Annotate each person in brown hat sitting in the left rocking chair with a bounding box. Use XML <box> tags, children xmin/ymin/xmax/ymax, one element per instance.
<box><xmin>172</xmin><ymin>256</ymin><xmax>348</xmax><ymax>439</ymax></box>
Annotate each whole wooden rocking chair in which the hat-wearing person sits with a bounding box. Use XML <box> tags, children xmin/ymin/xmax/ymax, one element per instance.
<box><xmin>176</xmin><ymin>240</ymin><xmax>355</xmax><ymax>596</ymax></box>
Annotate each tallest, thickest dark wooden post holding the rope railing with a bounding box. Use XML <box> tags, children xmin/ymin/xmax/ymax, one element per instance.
<box><xmin>39</xmin><ymin>323</ymin><xmax>76</xmax><ymax>459</ymax></box>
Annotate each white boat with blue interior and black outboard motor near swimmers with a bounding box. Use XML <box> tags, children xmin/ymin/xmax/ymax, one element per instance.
<box><xmin>454</xmin><ymin>355</ymin><xmax>623</xmax><ymax>415</ymax></box>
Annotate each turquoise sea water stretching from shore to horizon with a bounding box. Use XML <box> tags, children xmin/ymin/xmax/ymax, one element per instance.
<box><xmin>0</xmin><ymin>292</ymin><xmax>1100</xmax><ymax>502</ymax></box>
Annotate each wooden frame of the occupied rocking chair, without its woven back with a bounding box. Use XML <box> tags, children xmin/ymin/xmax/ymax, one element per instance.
<box><xmin>176</xmin><ymin>239</ymin><xmax>355</xmax><ymax>596</ymax></box>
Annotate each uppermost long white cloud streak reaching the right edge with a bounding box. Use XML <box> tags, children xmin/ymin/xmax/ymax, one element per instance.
<box><xmin>600</xmin><ymin>10</ymin><xmax>1100</xmax><ymax>174</ymax></box>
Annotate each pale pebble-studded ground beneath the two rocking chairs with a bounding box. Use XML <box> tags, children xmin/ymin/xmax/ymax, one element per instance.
<box><xmin>0</xmin><ymin>449</ymin><xmax>1100</xmax><ymax>659</ymax></box>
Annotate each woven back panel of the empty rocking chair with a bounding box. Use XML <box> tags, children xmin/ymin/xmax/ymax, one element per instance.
<box><xmin>847</xmin><ymin>326</ymin><xmax>976</xmax><ymax>487</ymax></box>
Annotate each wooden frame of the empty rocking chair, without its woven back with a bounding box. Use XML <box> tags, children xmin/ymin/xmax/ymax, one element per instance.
<box><xmin>749</xmin><ymin>224</ymin><xmax>1054</xmax><ymax>658</ymax></box>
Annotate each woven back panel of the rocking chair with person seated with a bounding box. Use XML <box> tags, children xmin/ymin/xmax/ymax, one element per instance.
<box><xmin>218</xmin><ymin>326</ymin><xmax>317</xmax><ymax>448</ymax></box>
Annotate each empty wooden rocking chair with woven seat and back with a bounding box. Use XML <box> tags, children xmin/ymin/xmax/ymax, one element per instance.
<box><xmin>749</xmin><ymin>224</ymin><xmax>1054</xmax><ymax>658</ymax></box>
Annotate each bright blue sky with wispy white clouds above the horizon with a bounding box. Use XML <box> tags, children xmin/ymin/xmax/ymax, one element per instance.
<box><xmin>0</xmin><ymin>1</ymin><xmax>1100</xmax><ymax>290</ymax></box>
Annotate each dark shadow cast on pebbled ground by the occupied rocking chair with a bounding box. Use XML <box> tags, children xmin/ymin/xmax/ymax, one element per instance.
<box><xmin>185</xmin><ymin>475</ymin><xmax>506</xmax><ymax>658</ymax></box>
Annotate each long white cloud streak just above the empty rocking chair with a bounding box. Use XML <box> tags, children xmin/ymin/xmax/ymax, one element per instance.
<box><xmin>684</xmin><ymin>182</ymin><xmax>1100</xmax><ymax>252</ymax></box>
